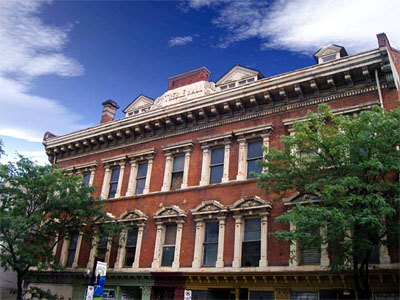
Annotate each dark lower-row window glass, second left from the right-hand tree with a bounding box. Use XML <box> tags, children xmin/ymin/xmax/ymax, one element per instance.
<box><xmin>203</xmin><ymin>222</ymin><xmax>219</xmax><ymax>266</ymax></box>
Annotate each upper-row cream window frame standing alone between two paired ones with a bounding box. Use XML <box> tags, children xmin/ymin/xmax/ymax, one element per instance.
<box><xmin>161</xmin><ymin>140</ymin><xmax>194</xmax><ymax>192</ymax></box>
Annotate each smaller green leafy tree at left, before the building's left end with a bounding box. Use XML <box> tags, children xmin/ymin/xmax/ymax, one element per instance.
<box><xmin>0</xmin><ymin>157</ymin><xmax>121</xmax><ymax>299</ymax></box>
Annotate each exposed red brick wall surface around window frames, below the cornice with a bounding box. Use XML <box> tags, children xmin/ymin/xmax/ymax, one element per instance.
<box><xmin>58</xmin><ymin>90</ymin><xmax>398</xmax><ymax>267</ymax></box>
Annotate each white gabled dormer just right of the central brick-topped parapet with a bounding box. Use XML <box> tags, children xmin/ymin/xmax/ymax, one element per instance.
<box><xmin>215</xmin><ymin>64</ymin><xmax>264</xmax><ymax>90</ymax></box>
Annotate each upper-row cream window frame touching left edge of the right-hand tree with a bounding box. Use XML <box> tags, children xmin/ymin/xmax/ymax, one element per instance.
<box><xmin>233</xmin><ymin>124</ymin><xmax>273</xmax><ymax>180</ymax></box>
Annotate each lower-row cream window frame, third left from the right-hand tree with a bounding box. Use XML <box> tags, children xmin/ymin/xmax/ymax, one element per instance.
<box><xmin>151</xmin><ymin>205</ymin><xmax>186</xmax><ymax>269</ymax></box>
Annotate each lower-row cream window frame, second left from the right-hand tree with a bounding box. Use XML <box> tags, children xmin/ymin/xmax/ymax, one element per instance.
<box><xmin>191</xmin><ymin>200</ymin><xmax>228</xmax><ymax>268</ymax></box>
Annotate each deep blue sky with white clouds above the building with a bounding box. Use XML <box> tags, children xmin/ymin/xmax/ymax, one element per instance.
<box><xmin>0</xmin><ymin>0</ymin><xmax>400</xmax><ymax>164</ymax></box>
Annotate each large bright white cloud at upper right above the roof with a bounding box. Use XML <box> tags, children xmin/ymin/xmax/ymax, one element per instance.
<box><xmin>188</xmin><ymin>0</ymin><xmax>400</xmax><ymax>53</ymax></box>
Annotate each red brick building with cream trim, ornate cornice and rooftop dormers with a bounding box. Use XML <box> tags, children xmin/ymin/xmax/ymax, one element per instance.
<box><xmin>37</xmin><ymin>34</ymin><xmax>400</xmax><ymax>299</ymax></box>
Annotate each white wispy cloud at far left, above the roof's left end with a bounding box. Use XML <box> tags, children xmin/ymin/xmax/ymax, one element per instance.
<box><xmin>0</xmin><ymin>0</ymin><xmax>85</xmax><ymax>142</ymax></box>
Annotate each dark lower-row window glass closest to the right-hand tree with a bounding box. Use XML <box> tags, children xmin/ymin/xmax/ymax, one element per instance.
<box><xmin>242</xmin><ymin>219</ymin><xmax>261</xmax><ymax>267</ymax></box>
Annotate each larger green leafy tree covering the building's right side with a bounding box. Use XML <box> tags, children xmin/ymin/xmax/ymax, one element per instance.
<box><xmin>258</xmin><ymin>105</ymin><xmax>400</xmax><ymax>299</ymax></box>
